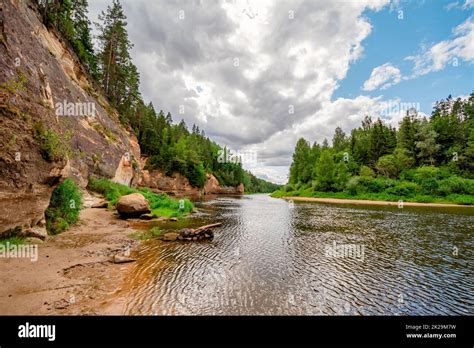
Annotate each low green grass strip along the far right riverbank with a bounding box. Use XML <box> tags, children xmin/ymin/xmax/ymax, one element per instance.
<box><xmin>271</xmin><ymin>189</ymin><xmax>474</xmax><ymax>205</ymax></box>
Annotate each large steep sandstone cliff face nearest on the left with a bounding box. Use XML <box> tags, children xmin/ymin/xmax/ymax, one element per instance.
<box><xmin>0</xmin><ymin>0</ymin><xmax>140</xmax><ymax>238</ymax></box>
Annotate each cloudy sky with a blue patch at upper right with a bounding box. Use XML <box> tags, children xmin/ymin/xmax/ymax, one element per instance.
<box><xmin>89</xmin><ymin>0</ymin><xmax>474</xmax><ymax>183</ymax></box>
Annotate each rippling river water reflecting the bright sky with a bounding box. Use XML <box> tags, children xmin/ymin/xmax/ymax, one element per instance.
<box><xmin>126</xmin><ymin>195</ymin><xmax>474</xmax><ymax>315</ymax></box>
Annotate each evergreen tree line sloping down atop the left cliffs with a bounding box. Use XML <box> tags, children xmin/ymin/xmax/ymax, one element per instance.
<box><xmin>33</xmin><ymin>0</ymin><xmax>278</xmax><ymax>192</ymax></box>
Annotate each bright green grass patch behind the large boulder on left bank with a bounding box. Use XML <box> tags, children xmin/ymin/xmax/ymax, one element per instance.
<box><xmin>88</xmin><ymin>179</ymin><xmax>194</xmax><ymax>217</ymax></box>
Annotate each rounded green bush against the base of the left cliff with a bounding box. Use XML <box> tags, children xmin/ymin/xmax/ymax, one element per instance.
<box><xmin>45</xmin><ymin>179</ymin><xmax>82</xmax><ymax>234</ymax></box>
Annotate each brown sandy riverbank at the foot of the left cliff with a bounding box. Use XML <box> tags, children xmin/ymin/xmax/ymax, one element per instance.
<box><xmin>0</xmin><ymin>208</ymin><xmax>139</xmax><ymax>315</ymax></box>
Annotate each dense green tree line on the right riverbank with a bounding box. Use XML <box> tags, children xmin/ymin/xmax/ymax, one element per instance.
<box><xmin>285</xmin><ymin>93</ymin><xmax>474</xmax><ymax>203</ymax></box>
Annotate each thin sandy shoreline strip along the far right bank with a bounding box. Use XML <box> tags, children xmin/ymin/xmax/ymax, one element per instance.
<box><xmin>274</xmin><ymin>196</ymin><xmax>474</xmax><ymax>208</ymax></box>
